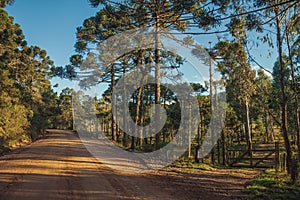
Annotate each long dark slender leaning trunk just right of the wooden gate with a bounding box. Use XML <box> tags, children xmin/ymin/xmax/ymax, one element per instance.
<box><xmin>274</xmin><ymin>7</ymin><xmax>292</xmax><ymax>174</ymax></box>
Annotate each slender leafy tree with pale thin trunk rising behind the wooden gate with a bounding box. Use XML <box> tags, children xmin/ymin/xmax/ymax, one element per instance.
<box><xmin>215</xmin><ymin>41</ymin><xmax>256</xmax><ymax>162</ymax></box>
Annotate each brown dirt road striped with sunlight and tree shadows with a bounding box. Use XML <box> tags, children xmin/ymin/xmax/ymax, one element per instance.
<box><xmin>0</xmin><ymin>131</ymin><xmax>258</xmax><ymax>200</ymax></box>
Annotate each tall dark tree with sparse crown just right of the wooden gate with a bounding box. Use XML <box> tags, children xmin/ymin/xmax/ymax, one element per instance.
<box><xmin>251</xmin><ymin>0</ymin><xmax>300</xmax><ymax>173</ymax></box>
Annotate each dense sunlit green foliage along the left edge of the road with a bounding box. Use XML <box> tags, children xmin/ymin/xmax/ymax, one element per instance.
<box><xmin>0</xmin><ymin>6</ymin><xmax>65</xmax><ymax>148</ymax></box>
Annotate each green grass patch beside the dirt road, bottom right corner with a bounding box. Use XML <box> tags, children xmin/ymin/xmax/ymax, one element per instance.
<box><xmin>247</xmin><ymin>169</ymin><xmax>300</xmax><ymax>200</ymax></box>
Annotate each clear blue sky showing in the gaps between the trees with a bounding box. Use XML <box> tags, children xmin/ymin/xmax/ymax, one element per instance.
<box><xmin>6</xmin><ymin>0</ymin><xmax>275</xmax><ymax>94</ymax></box>
